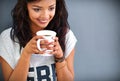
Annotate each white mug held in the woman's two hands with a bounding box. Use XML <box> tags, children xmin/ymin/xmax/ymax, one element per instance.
<box><xmin>36</xmin><ymin>30</ymin><xmax>56</xmax><ymax>56</ymax></box>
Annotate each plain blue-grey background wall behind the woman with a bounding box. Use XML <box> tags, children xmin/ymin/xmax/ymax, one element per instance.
<box><xmin>0</xmin><ymin>0</ymin><xmax>120</xmax><ymax>81</ymax></box>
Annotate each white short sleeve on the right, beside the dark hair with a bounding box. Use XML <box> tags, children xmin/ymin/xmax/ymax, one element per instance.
<box><xmin>65</xmin><ymin>30</ymin><xmax>77</xmax><ymax>58</ymax></box>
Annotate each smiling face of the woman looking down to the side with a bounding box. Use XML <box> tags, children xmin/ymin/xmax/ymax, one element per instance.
<box><xmin>27</xmin><ymin>0</ymin><xmax>56</xmax><ymax>31</ymax></box>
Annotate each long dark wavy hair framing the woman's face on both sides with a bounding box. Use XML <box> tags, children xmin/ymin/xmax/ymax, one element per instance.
<box><xmin>11</xmin><ymin>0</ymin><xmax>70</xmax><ymax>52</ymax></box>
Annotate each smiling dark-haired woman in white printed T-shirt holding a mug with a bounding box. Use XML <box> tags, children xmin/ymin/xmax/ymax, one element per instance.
<box><xmin>0</xmin><ymin>0</ymin><xmax>77</xmax><ymax>81</ymax></box>
